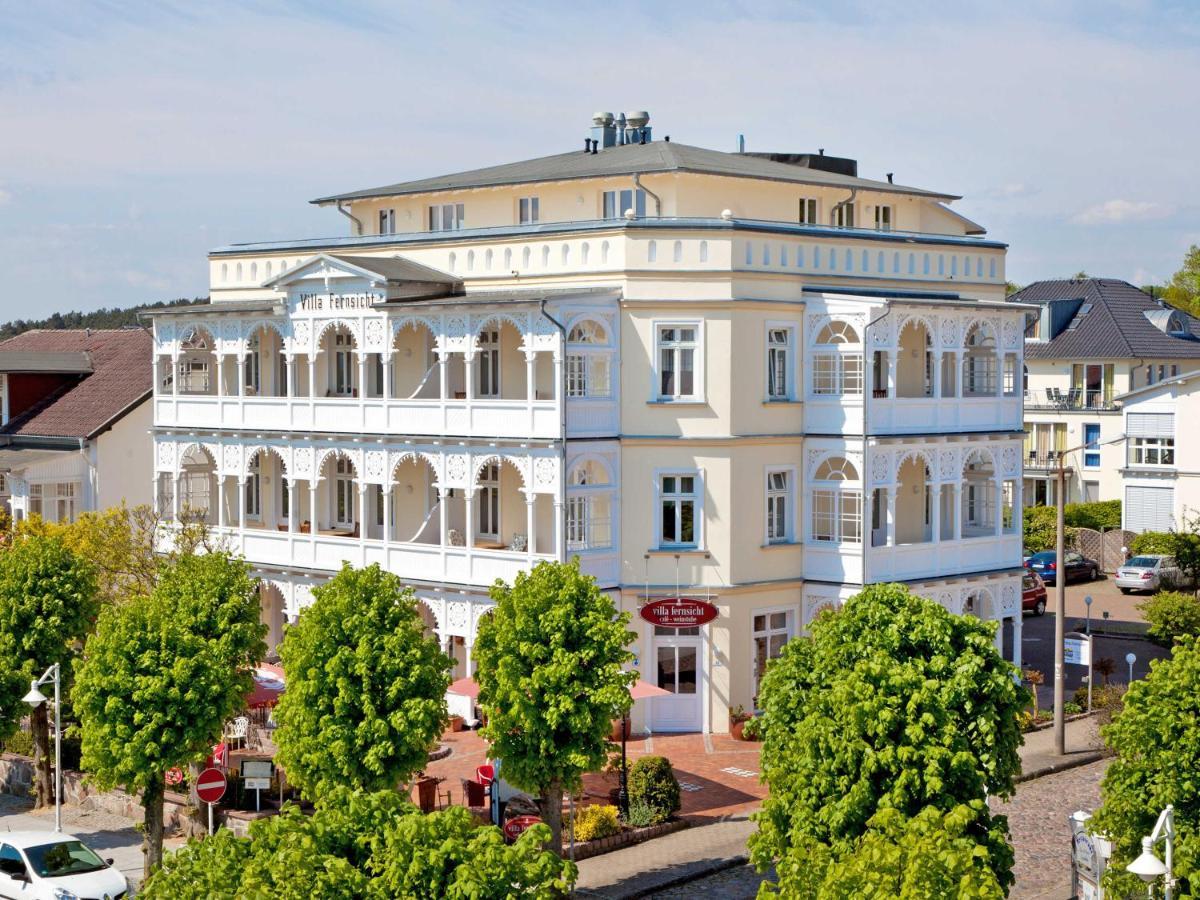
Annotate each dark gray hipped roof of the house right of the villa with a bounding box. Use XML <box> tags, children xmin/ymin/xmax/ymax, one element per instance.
<box><xmin>1008</xmin><ymin>278</ymin><xmax>1200</xmax><ymax>359</ymax></box>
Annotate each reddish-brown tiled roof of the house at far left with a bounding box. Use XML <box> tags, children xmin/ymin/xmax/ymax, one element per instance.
<box><xmin>0</xmin><ymin>329</ymin><xmax>154</xmax><ymax>438</ymax></box>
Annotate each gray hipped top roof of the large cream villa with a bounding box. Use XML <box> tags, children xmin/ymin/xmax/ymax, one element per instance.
<box><xmin>312</xmin><ymin>140</ymin><xmax>959</xmax><ymax>204</ymax></box>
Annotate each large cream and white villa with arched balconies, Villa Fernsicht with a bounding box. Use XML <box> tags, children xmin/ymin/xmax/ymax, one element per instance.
<box><xmin>152</xmin><ymin>116</ymin><xmax>1027</xmax><ymax>731</ymax></box>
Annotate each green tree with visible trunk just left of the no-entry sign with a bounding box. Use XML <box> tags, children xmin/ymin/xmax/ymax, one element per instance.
<box><xmin>73</xmin><ymin>553</ymin><xmax>266</xmax><ymax>875</ymax></box>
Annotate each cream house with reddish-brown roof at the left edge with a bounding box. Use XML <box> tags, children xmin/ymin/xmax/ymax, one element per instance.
<box><xmin>0</xmin><ymin>328</ymin><xmax>154</xmax><ymax>522</ymax></box>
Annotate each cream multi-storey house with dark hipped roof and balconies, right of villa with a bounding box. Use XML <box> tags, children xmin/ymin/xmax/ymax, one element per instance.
<box><xmin>1009</xmin><ymin>278</ymin><xmax>1200</xmax><ymax>505</ymax></box>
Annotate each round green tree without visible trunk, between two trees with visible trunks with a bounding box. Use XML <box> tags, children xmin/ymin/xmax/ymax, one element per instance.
<box><xmin>275</xmin><ymin>564</ymin><xmax>451</xmax><ymax>798</ymax></box>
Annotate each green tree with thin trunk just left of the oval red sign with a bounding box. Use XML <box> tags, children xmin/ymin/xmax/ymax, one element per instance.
<box><xmin>474</xmin><ymin>559</ymin><xmax>637</xmax><ymax>852</ymax></box>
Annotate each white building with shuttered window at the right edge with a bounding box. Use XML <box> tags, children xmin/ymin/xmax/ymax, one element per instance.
<box><xmin>1117</xmin><ymin>370</ymin><xmax>1200</xmax><ymax>532</ymax></box>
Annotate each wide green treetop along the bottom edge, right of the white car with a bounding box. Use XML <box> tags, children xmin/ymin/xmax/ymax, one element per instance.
<box><xmin>139</xmin><ymin>792</ymin><xmax>577</xmax><ymax>900</ymax></box>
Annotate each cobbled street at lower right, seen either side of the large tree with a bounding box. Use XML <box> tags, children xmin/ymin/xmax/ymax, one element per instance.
<box><xmin>648</xmin><ymin>760</ymin><xmax>1110</xmax><ymax>900</ymax></box>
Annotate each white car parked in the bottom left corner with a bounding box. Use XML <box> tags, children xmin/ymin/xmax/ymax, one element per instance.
<box><xmin>0</xmin><ymin>832</ymin><xmax>130</xmax><ymax>900</ymax></box>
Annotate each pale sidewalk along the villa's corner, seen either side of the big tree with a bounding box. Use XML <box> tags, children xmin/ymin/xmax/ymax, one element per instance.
<box><xmin>576</xmin><ymin>716</ymin><xmax>1102</xmax><ymax>899</ymax></box>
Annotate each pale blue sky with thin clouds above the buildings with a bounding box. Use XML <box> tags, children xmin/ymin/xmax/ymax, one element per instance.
<box><xmin>0</xmin><ymin>0</ymin><xmax>1200</xmax><ymax>320</ymax></box>
